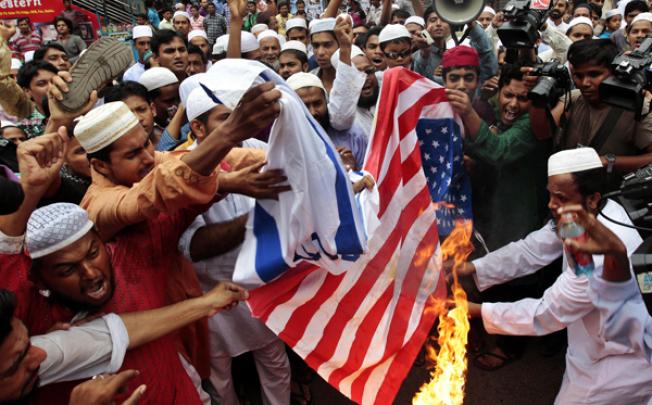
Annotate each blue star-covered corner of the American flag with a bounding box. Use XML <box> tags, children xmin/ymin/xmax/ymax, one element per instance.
<box><xmin>417</xmin><ymin>117</ymin><xmax>473</xmax><ymax>235</ymax></box>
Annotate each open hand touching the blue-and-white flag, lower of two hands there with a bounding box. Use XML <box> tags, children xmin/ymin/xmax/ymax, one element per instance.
<box><xmin>220</xmin><ymin>162</ymin><xmax>292</xmax><ymax>200</ymax></box>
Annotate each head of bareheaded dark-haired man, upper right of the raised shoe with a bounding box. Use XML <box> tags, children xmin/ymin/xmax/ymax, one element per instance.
<box><xmin>151</xmin><ymin>30</ymin><xmax>188</xmax><ymax>81</ymax></box>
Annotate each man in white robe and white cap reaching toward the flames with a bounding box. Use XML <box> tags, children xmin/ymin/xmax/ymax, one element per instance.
<box><xmin>450</xmin><ymin>148</ymin><xmax>652</xmax><ymax>404</ymax></box>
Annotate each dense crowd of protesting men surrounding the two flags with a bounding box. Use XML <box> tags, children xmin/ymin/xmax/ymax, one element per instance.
<box><xmin>0</xmin><ymin>0</ymin><xmax>652</xmax><ymax>404</ymax></box>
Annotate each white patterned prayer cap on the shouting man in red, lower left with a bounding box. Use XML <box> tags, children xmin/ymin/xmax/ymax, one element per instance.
<box><xmin>25</xmin><ymin>203</ymin><xmax>93</xmax><ymax>259</ymax></box>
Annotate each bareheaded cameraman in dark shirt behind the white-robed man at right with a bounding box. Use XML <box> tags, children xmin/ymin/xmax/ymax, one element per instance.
<box><xmin>552</xmin><ymin>39</ymin><xmax>652</xmax><ymax>183</ymax></box>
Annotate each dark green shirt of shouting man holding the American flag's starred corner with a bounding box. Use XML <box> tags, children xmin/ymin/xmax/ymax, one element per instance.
<box><xmin>465</xmin><ymin>114</ymin><xmax>552</xmax><ymax>250</ymax></box>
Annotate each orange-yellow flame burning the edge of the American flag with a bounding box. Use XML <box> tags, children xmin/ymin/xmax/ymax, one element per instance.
<box><xmin>412</xmin><ymin>221</ymin><xmax>473</xmax><ymax>405</ymax></box>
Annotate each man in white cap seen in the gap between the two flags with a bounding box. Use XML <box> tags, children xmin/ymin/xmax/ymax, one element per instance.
<box><xmin>287</xmin><ymin>72</ymin><xmax>367</xmax><ymax>168</ymax></box>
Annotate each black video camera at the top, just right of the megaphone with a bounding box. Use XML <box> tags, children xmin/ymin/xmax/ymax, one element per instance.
<box><xmin>498</xmin><ymin>0</ymin><xmax>548</xmax><ymax>48</ymax></box>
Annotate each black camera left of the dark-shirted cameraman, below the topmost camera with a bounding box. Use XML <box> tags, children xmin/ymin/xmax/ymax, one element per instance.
<box><xmin>527</xmin><ymin>60</ymin><xmax>571</xmax><ymax>108</ymax></box>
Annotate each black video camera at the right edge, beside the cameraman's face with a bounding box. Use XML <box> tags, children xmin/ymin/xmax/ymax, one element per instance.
<box><xmin>600</xmin><ymin>36</ymin><xmax>652</xmax><ymax>120</ymax></box>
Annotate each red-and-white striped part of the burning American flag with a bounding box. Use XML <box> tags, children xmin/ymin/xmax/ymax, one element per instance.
<box><xmin>248</xmin><ymin>68</ymin><xmax>453</xmax><ymax>404</ymax></box>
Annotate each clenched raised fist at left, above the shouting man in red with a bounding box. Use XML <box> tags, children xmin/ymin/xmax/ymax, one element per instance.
<box><xmin>16</xmin><ymin>127</ymin><xmax>69</xmax><ymax>194</ymax></box>
